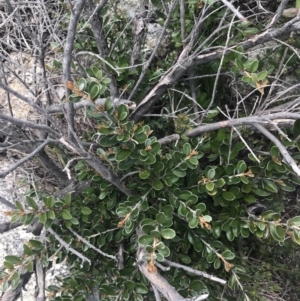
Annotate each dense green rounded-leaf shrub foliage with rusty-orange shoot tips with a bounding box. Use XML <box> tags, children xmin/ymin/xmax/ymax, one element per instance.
<box><xmin>1</xmin><ymin>0</ymin><xmax>300</xmax><ymax>301</ymax></box>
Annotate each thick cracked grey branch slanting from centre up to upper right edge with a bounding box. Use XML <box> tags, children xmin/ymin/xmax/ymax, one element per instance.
<box><xmin>130</xmin><ymin>16</ymin><xmax>300</xmax><ymax>122</ymax></box>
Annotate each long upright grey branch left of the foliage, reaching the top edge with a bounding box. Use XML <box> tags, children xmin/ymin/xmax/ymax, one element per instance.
<box><xmin>63</xmin><ymin>0</ymin><xmax>85</xmax><ymax>144</ymax></box>
